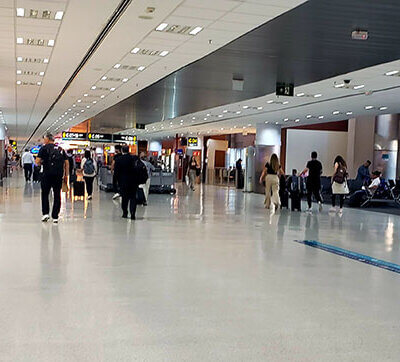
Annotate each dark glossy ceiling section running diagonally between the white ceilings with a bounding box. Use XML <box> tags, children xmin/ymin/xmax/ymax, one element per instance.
<box><xmin>92</xmin><ymin>0</ymin><xmax>400</xmax><ymax>131</ymax></box>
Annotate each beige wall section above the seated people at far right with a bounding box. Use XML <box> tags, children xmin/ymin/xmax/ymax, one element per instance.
<box><xmin>347</xmin><ymin>116</ymin><xmax>375</xmax><ymax>178</ymax></box>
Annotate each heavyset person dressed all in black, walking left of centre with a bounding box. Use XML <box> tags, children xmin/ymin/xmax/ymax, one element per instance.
<box><xmin>114</xmin><ymin>146</ymin><xmax>140</xmax><ymax>220</ymax></box>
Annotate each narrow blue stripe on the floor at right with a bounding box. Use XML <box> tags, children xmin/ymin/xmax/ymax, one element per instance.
<box><xmin>295</xmin><ymin>240</ymin><xmax>400</xmax><ymax>274</ymax></box>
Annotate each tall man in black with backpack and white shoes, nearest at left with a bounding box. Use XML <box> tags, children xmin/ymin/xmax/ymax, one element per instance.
<box><xmin>36</xmin><ymin>133</ymin><xmax>69</xmax><ymax>224</ymax></box>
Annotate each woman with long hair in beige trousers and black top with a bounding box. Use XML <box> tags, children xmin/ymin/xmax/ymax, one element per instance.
<box><xmin>260</xmin><ymin>153</ymin><xmax>281</xmax><ymax>214</ymax></box>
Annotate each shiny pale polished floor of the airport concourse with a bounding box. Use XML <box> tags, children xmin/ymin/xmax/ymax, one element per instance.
<box><xmin>0</xmin><ymin>178</ymin><xmax>400</xmax><ymax>362</ymax></box>
